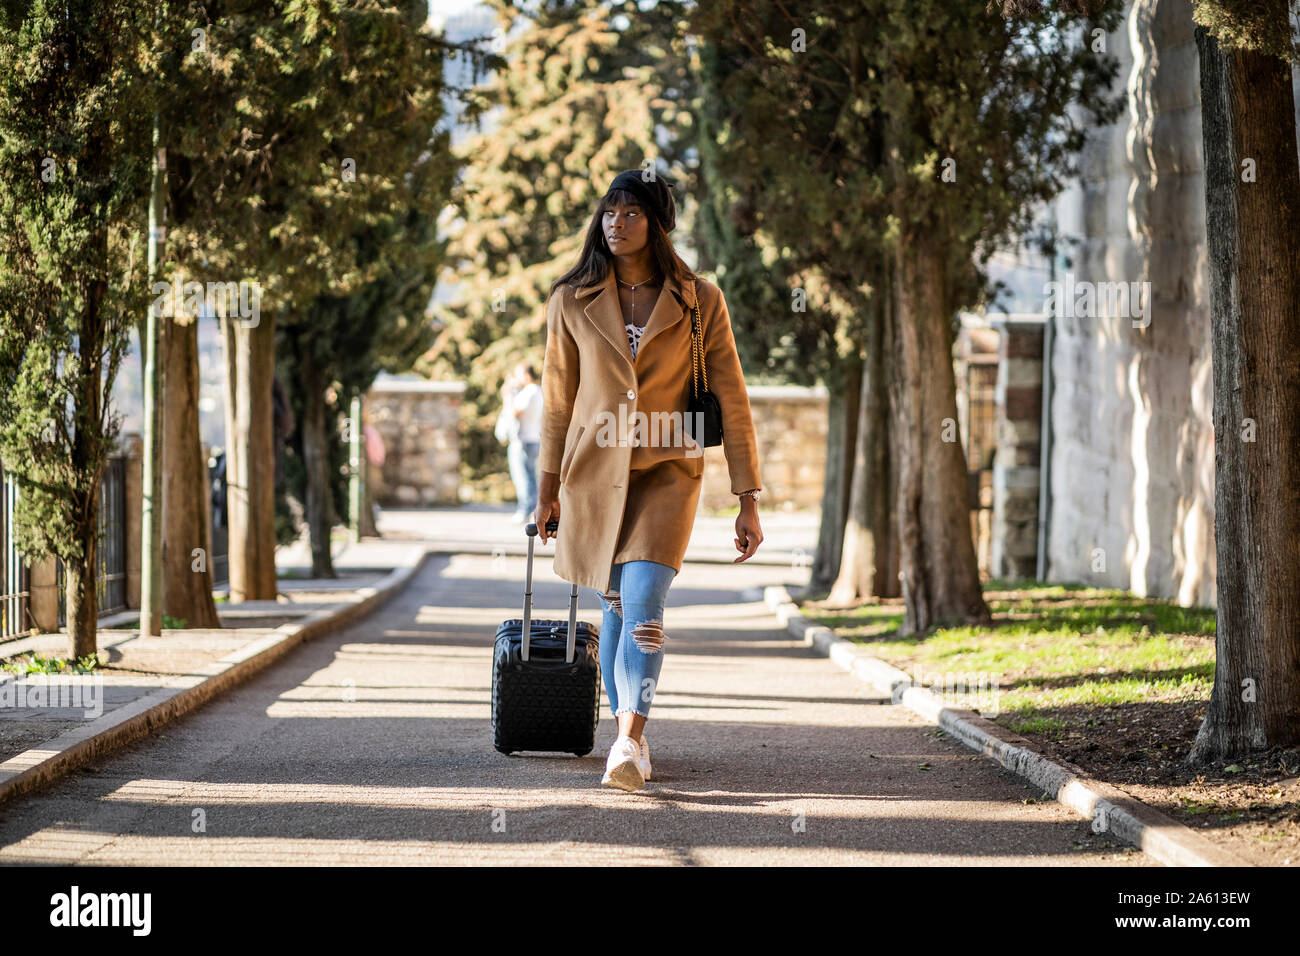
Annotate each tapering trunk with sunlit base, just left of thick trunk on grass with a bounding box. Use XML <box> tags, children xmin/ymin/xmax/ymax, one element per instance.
<box><xmin>828</xmin><ymin>282</ymin><xmax>897</xmax><ymax>607</ymax></box>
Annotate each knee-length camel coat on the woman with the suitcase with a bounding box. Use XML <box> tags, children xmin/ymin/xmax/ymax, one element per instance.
<box><xmin>537</xmin><ymin>269</ymin><xmax>762</xmax><ymax>592</ymax></box>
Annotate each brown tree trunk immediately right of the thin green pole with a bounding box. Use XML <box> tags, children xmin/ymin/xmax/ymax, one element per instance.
<box><xmin>161</xmin><ymin>295</ymin><xmax>221</xmax><ymax>627</ymax></box>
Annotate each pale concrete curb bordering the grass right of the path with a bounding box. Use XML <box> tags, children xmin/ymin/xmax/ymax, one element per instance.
<box><xmin>763</xmin><ymin>585</ymin><xmax>1255</xmax><ymax>866</ymax></box>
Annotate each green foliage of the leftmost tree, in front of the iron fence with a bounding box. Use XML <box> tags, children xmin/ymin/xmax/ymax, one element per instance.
<box><xmin>0</xmin><ymin>0</ymin><xmax>150</xmax><ymax>590</ymax></box>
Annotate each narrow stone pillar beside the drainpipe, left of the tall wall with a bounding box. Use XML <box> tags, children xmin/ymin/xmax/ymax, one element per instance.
<box><xmin>992</xmin><ymin>316</ymin><xmax>1044</xmax><ymax>579</ymax></box>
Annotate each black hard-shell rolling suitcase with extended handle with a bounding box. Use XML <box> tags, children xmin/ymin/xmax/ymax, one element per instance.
<box><xmin>491</xmin><ymin>520</ymin><xmax>601</xmax><ymax>757</ymax></box>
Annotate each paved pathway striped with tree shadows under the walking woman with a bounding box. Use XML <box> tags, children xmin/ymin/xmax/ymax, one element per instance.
<box><xmin>0</xmin><ymin>550</ymin><xmax>1151</xmax><ymax>865</ymax></box>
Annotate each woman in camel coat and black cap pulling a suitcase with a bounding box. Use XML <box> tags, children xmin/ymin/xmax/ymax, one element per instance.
<box><xmin>537</xmin><ymin>169</ymin><xmax>763</xmax><ymax>791</ymax></box>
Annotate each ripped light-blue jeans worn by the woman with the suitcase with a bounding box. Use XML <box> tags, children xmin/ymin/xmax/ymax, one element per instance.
<box><xmin>597</xmin><ymin>561</ymin><xmax>677</xmax><ymax>719</ymax></box>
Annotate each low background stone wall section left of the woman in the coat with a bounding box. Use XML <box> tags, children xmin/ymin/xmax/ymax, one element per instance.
<box><xmin>363</xmin><ymin>376</ymin><xmax>465</xmax><ymax>507</ymax></box>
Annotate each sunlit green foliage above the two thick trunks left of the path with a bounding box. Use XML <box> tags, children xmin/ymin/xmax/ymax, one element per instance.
<box><xmin>160</xmin><ymin>0</ymin><xmax>460</xmax><ymax>310</ymax></box>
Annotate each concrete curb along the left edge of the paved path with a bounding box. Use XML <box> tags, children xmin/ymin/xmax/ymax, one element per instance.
<box><xmin>0</xmin><ymin>550</ymin><xmax>439</xmax><ymax>803</ymax></box>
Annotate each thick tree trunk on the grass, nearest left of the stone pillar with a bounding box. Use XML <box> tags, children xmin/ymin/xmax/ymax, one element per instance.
<box><xmin>892</xmin><ymin>221</ymin><xmax>992</xmax><ymax>633</ymax></box>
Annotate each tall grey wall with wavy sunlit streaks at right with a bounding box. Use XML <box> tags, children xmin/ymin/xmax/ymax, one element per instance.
<box><xmin>1048</xmin><ymin>0</ymin><xmax>1216</xmax><ymax>605</ymax></box>
